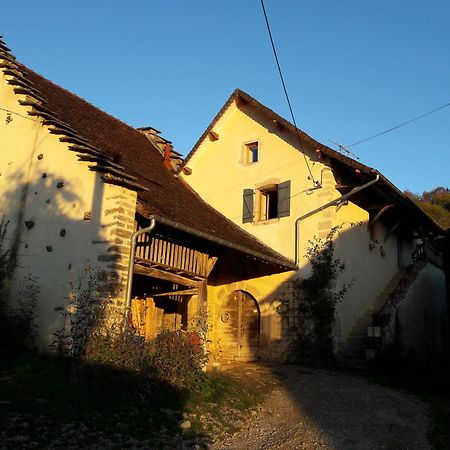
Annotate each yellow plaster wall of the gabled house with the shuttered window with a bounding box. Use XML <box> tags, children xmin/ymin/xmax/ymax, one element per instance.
<box><xmin>183</xmin><ymin>105</ymin><xmax>411</xmax><ymax>352</ymax></box>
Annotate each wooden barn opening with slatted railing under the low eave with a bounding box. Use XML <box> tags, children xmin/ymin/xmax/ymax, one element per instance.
<box><xmin>130</xmin><ymin>215</ymin><xmax>218</xmax><ymax>339</ymax></box>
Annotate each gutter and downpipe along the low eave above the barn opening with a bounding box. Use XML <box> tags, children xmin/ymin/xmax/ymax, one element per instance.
<box><xmin>124</xmin><ymin>214</ymin><xmax>295</xmax><ymax>327</ymax></box>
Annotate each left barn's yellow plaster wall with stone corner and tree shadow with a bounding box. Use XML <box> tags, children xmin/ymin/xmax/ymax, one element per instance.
<box><xmin>0</xmin><ymin>74</ymin><xmax>136</xmax><ymax>350</ymax></box>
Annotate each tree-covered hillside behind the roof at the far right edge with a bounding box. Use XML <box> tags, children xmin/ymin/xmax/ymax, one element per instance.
<box><xmin>405</xmin><ymin>187</ymin><xmax>450</xmax><ymax>229</ymax></box>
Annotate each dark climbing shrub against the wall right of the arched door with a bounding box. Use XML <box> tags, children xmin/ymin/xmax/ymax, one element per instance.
<box><xmin>293</xmin><ymin>225</ymin><xmax>353</xmax><ymax>361</ymax></box>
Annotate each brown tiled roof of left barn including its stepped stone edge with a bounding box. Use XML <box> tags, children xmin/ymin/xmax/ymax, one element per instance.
<box><xmin>0</xmin><ymin>39</ymin><xmax>294</xmax><ymax>269</ymax></box>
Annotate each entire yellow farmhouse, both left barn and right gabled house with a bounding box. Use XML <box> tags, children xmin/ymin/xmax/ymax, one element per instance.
<box><xmin>0</xmin><ymin>40</ymin><xmax>446</xmax><ymax>363</ymax></box>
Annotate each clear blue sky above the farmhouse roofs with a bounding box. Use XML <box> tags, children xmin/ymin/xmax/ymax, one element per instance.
<box><xmin>0</xmin><ymin>0</ymin><xmax>450</xmax><ymax>192</ymax></box>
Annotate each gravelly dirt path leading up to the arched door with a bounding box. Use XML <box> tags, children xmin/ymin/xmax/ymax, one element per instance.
<box><xmin>210</xmin><ymin>365</ymin><xmax>430</xmax><ymax>450</ymax></box>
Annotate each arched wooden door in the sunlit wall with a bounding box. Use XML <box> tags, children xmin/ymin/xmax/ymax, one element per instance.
<box><xmin>220</xmin><ymin>291</ymin><xmax>261</xmax><ymax>361</ymax></box>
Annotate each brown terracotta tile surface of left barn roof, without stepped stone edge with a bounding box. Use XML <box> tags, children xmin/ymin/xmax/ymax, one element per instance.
<box><xmin>9</xmin><ymin>66</ymin><xmax>294</xmax><ymax>269</ymax></box>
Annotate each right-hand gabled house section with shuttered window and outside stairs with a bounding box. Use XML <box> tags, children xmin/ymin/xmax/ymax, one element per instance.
<box><xmin>182</xmin><ymin>89</ymin><xmax>447</xmax><ymax>359</ymax></box>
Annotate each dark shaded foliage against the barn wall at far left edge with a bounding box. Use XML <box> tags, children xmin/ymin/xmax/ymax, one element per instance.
<box><xmin>0</xmin><ymin>217</ymin><xmax>39</xmax><ymax>354</ymax></box>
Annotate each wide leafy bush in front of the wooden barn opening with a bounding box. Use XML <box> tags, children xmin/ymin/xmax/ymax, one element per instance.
<box><xmin>81</xmin><ymin>330</ymin><xmax>206</xmax><ymax>399</ymax></box>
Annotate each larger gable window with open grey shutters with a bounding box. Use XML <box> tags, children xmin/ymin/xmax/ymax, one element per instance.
<box><xmin>242</xmin><ymin>180</ymin><xmax>291</xmax><ymax>223</ymax></box>
